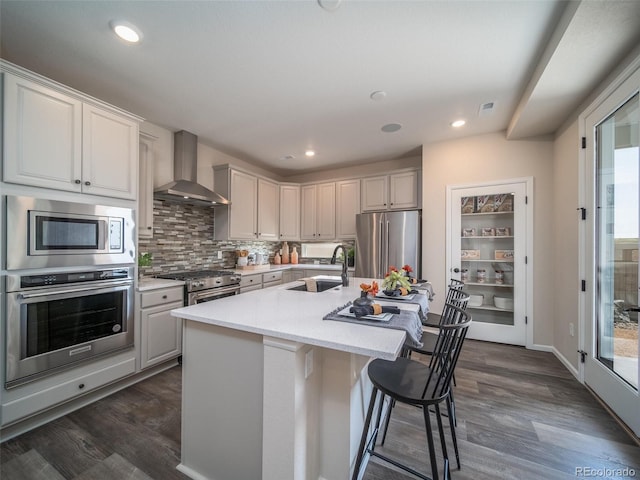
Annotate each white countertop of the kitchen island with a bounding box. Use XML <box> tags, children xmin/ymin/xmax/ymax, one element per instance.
<box><xmin>171</xmin><ymin>277</ymin><xmax>405</xmax><ymax>360</ymax></box>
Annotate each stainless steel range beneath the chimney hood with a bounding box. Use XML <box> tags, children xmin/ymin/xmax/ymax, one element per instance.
<box><xmin>158</xmin><ymin>270</ymin><xmax>240</xmax><ymax>305</ymax></box>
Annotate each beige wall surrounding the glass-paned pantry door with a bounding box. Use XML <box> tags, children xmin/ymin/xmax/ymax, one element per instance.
<box><xmin>422</xmin><ymin>133</ymin><xmax>554</xmax><ymax>348</ymax></box>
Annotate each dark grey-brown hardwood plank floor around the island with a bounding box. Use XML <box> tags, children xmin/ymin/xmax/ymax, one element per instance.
<box><xmin>0</xmin><ymin>340</ymin><xmax>640</xmax><ymax>480</ymax></box>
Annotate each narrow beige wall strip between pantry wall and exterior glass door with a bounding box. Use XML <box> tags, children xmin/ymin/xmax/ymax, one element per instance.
<box><xmin>552</xmin><ymin>121</ymin><xmax>581</xmax><ymax>374</ymax></box>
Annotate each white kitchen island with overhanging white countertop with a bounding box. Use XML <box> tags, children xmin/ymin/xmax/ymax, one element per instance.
<box><xmin>172</xmin><ymin>277</ymin><xmax>405</xmax><ymax>480</ymax></box>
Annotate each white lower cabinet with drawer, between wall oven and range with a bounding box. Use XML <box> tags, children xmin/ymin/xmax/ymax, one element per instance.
<box><xmin>139</xmin><ymin>287</ymin><xmax>184</xmax><ymax>369</ymax></box>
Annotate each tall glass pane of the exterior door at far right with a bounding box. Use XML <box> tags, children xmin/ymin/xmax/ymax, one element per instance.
<box><xmin>595</xmin><ymin>94</ymin><xmax>640</xmax><ymax>390</ymax></box>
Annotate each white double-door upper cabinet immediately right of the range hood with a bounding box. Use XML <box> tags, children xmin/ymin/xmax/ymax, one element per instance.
<box><xmin>213</xmin><ymin>165</ymin><xmax>279</xmax><ymax>241</ymax></box>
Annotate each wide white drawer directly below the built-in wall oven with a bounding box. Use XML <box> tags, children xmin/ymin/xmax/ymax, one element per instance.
<box><xmin>2</xmin><ymin>358</ymin><xmax>136</xmax><ymax>425</ymax></box>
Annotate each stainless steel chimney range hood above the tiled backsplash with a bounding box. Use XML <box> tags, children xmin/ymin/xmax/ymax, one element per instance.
<box><xmin>153</xmin><ymin>130</ymin><xmax>231</xmax><ymax>207</ymax></box>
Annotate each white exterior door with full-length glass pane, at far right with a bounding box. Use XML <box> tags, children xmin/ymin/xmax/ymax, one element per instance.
<box><xmin>581</xmin><ymin>65</ymin><xmax>640</xmax><ymax>435</ymax></box>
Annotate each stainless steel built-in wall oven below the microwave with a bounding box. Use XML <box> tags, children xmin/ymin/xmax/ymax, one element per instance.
<box><xmin>5</xmin><ymin>267</ymin><xmax>134</xmax><ymax>388</ymax></box>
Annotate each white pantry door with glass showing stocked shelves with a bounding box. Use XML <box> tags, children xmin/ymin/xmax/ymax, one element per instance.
<box><xmin>447</xmin><ymin>181</ymin><xmax>528</xmax><ymax>345</ymax></box>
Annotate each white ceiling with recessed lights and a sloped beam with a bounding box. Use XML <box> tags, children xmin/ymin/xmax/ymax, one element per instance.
<box><xmin>0</xmin><ymin>0</ymin><xmax>640</xmax><ymax>176</ymax></box>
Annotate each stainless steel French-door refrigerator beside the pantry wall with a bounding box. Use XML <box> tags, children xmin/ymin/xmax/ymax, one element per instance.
<box><xmin>356</xmin><ymin>210</ymin><xmax>422</xmax><ymax>278</ymax></box>
